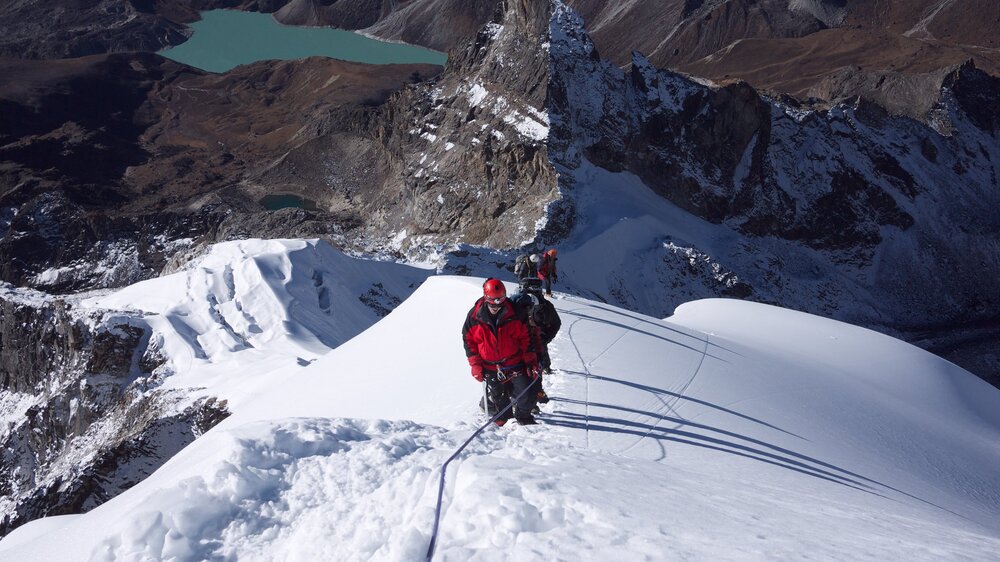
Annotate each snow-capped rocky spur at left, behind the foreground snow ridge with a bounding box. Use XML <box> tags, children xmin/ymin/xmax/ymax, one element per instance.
<box><xmin>0</xmin><ymin>236</ymin><xmax>431</xmax><ymax>533</ymax></box>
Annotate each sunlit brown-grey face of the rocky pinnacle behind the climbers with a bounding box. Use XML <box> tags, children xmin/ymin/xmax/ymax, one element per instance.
<box><xmin>265</xmin><ymin>0</ymin><xmax>555</xmax><ymax>251</ymax></box>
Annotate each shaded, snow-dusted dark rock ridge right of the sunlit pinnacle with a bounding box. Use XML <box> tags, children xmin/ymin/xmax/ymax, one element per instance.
<box><xmin>548</xmin><ymin>1</ymin><xmax>1000</xmax><ymax>380</ymax></box>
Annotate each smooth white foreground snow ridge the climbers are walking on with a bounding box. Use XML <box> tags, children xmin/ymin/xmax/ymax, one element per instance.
<box><xmin>0</xmin><ymin>256</ymin><xmax>1000</xmax><ymax>560</ymax></box>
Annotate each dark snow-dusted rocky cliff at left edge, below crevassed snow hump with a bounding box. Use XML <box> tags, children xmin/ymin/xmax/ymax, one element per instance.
<box><xmin>0</xmin><ymin>287</ymin><xmax>228</xmax><ymax>534</ymax></box>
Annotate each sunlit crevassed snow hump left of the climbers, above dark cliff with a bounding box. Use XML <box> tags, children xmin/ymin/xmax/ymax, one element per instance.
<box><xmin>83</xmin><ymin>240</ymin><xmax>431</xmax><ymax>406</ymax></box>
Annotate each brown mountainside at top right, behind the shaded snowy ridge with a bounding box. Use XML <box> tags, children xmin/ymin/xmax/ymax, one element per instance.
<box><xmin>568</xmin><ymin>0</ymin><xmax>1000</xmax><ymax>118</ymax></box>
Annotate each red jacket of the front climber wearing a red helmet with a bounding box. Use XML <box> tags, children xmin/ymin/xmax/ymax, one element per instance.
<box><xmin>462</xmin><ymin>298</ymin><xmax>537</xmax><ymax>371</ymax></box>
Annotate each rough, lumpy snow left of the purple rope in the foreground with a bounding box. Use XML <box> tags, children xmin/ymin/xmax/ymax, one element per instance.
<box><xmin>92</xmin><ymin>418</ymin><xmax>454</xmax><ymax>560</ymax></box>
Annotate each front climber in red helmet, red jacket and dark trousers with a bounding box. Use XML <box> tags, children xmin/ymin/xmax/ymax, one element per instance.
<box><xmin>462</xmin><ymin>279</ymin><xmax>540</xmax><ymax>425</ymax></box>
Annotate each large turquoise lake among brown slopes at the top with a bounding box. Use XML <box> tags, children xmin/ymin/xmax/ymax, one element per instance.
<box><xmin>160</xmin><ymin>10</ymin><xmax>447</xmax><ymax>72</ymax></box>
